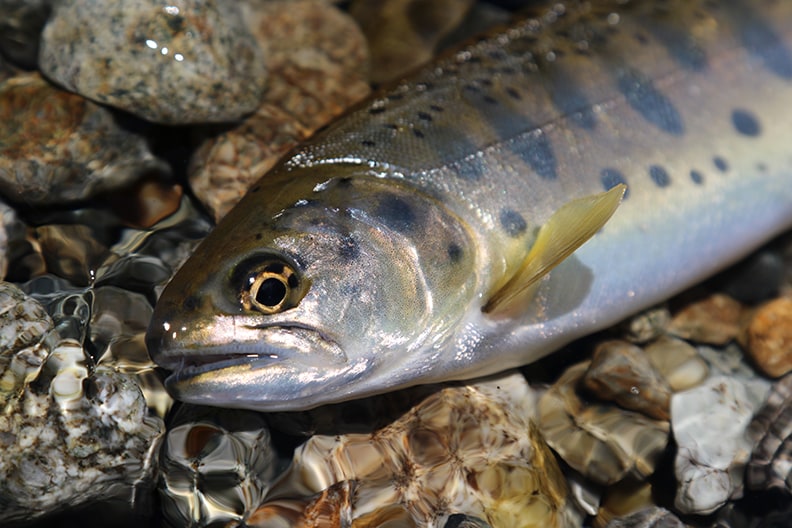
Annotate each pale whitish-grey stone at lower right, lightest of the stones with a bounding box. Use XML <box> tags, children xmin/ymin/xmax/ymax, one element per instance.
<box><xmin>671</xmin><ymin>375</ymin><xmax>769</xmax><ymax>514</ymax></box>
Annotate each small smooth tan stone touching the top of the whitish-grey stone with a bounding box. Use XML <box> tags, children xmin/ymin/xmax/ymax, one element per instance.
<box><xmin>644</xmin><ymin>336</ymin><xmax>709</xmax><ymax>391</ymax></box>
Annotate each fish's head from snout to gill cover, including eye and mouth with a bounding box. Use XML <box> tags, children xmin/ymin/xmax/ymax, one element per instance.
<box><xmin>147</xmin><ymin>165</ymin><xmax>470</xmax><ymax>411</ymax></box>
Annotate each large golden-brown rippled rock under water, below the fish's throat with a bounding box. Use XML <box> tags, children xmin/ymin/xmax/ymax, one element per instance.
<box><xmin>262</xmin><ymin>372</ymin><xmax>581</xmax><ymax>528</ymax></box>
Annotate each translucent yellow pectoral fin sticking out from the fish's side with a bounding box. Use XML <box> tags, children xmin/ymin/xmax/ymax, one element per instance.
<box><xmin>482</xmin><ymin>184</ymin><xmax>627</xmax><ymax>315</ymax></box>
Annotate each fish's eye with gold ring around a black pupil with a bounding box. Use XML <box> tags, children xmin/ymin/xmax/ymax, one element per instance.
<box><xmin>235</xmin><ymin>259</ymin><xmax>306</xmax><ymax>315</ymax></box>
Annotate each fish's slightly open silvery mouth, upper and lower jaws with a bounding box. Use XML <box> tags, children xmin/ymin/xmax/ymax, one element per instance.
<box><xmin>147</xmin><ymin>315</ymin><xmax>366</xmax><ymax>411</ymax></box>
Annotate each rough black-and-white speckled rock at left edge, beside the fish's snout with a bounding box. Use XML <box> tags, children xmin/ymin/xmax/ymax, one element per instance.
<box><xmin>0</xmin><ymin>283</ymin><xmax>164</xmax><ymax>522</ymax></box>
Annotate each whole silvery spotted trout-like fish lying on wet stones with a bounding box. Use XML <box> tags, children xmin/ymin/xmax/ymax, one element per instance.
<box><xmin>147</xmin><ymin>0</ymin><xmax>792</xmax><ymax>411</ymax></box>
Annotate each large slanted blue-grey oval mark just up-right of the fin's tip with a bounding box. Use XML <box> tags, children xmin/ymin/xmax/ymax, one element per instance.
<box><xmin>618</xmin><ymin>70</ymin><xmax>685</xmax><ymax>136</ymax></box>
